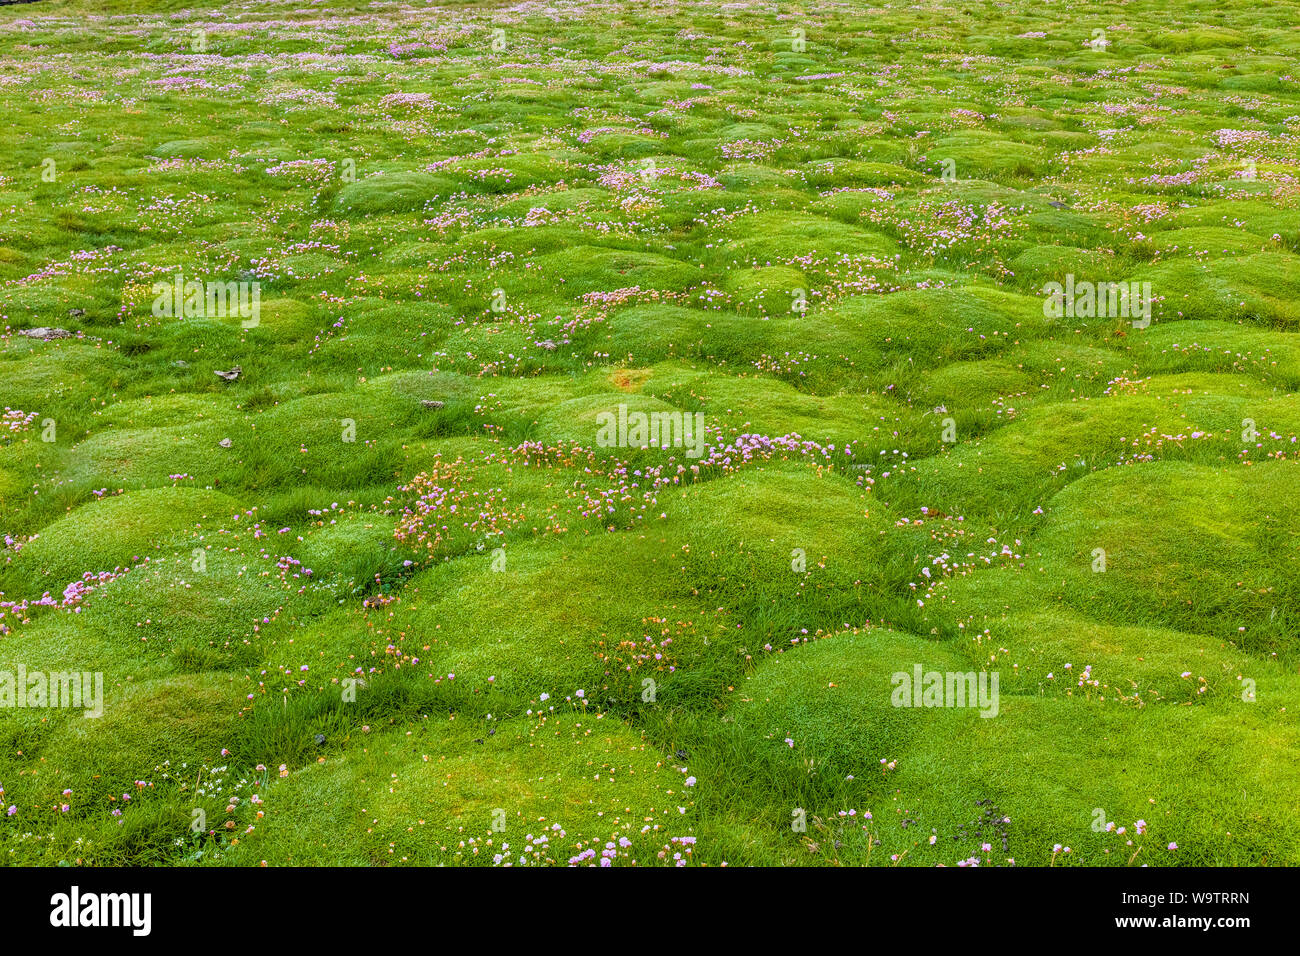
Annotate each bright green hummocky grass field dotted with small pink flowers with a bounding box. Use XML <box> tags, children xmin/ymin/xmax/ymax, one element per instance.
<box><xmin>0</xmin><ymin>0</ymin><xmax>1300</xmax><ymax>866</ymax></box>
